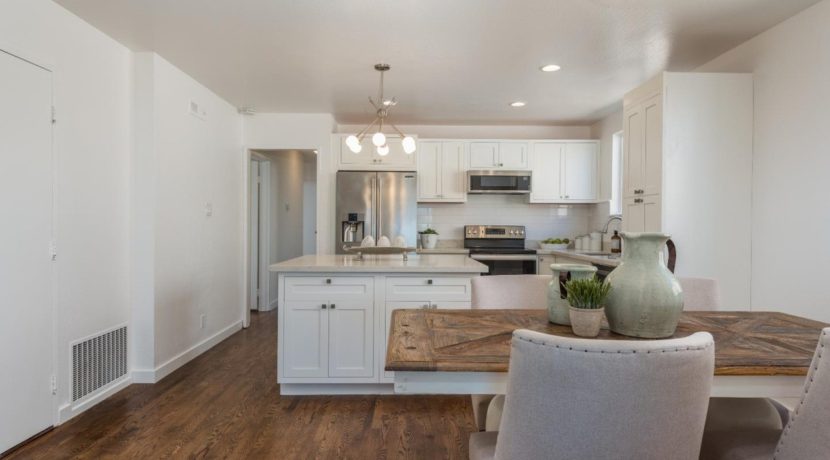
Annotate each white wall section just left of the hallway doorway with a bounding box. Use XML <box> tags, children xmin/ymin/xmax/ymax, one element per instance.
<box><xmin>136</xmin><ymin>53</ymin><xmax>244</xmax><ymax>379</ymax></box>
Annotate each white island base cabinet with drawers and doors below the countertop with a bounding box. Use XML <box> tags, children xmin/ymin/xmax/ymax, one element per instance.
<box><xmin>277</xmin><ymin>274</ymin><xmax>476</xmax><ymax>392</ymax></box>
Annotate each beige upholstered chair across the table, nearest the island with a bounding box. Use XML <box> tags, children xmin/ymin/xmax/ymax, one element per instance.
<box><xmin>472</xmin><ymin>275</ymin><xmax>553</xmax><ymax>431</ymax></box>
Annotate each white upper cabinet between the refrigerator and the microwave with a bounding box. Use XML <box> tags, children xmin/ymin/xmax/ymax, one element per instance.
<box><xmin>418</xmin><ymin>141</ymin><xmax>467</xmax><ymax>203</ymax></box>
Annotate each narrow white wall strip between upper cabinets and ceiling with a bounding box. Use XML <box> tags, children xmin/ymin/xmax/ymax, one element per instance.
<box><xmin>337</xmin><ymin>120</ymin><xmax>591</xmax><ymax>139</ymax></box>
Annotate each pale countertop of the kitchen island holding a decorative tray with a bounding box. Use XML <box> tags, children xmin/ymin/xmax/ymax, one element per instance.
<box><xmin>268</xmin><ymin>254</ymin><xmax>488</xmax><ymax>273</ymax></box>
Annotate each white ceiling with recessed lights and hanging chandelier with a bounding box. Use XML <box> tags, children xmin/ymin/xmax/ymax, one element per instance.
<box><xmin>56</xmin><ymin>0</ymin><xmax>817</xmax><ymax>124</ymax></box>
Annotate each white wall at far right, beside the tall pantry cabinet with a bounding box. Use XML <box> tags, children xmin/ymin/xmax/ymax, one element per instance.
<box><xmin>698</xmin><ymin>0</ymin><xmax>830</xmax><ymax>321</ymax></box>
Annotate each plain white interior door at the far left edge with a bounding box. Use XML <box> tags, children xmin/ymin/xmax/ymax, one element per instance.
<box><xmin>0</xmin><ymin>51</ymin><xmax>53</xmax><ymax>453</ymax></box>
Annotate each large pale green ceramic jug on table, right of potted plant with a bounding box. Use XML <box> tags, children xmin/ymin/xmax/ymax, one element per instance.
<box><xmin>605</xmin><ymin>232</ymin><xmax>683</xmax><ymax>339</ymax></box>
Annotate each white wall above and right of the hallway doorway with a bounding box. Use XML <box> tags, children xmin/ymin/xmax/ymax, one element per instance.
<box><xmin>244</xmin><ymin>113</ymin><xmax>336</xmax><ymax>254</ymax></box>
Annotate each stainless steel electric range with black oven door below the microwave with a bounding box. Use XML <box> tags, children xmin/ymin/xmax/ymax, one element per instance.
<box><xmin>464</xmin><ymin>225</ymin><xmax>536</xmax><ymax>275</ymax></box>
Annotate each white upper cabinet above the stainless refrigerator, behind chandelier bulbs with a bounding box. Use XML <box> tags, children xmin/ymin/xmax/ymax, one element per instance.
<box><xmin>332</xmin><ymin>134</ymin><xmax>418</xmax><ymax>171</ymax></box>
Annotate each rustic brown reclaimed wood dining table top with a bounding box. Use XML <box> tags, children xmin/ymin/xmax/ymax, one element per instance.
<box><xmin>386</xmin><ymin>309</ymin><xmax>828</xmax><ymax>376</ymax></box>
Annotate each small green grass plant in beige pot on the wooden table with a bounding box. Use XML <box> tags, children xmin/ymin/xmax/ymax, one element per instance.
<box><xmin>565</xmin><ymin>277</ymin><xmax>611</xmax><ymax>337</ymax></box>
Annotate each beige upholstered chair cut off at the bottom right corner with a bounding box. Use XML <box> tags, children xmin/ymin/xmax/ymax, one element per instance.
<box><xmin>700</xmin><ymin>328</ymin><xmax>830</xmax><ymax>460</ymax></box>
